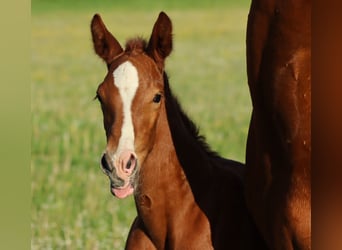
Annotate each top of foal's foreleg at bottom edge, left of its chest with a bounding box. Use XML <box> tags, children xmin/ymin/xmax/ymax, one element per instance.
<box><xmin>125</xmin><ymin>216</ymin><xmax>156</xmax><ymax>250</ymax></box>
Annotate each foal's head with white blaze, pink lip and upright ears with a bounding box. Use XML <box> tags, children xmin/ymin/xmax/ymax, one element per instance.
<box><xmin>91</xmin><ymin>12</ymin><xmax>172</xmax><ymax>198</ymax></box>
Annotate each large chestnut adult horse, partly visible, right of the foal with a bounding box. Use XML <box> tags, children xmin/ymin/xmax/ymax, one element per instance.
<box><xmin>246</xmin><ymin>0</ymin><xmax>311</xmax><ymax>250</ymax></box>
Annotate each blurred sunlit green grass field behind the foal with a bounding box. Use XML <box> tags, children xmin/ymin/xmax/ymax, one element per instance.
<box><xmin>31</xmin><ymin>0</ymin><xmax>251</xmax><ymax>250</ymax></box>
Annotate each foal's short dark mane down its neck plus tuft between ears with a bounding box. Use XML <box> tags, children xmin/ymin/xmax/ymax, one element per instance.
<box><xmin>125</xmin><ymin>37</ymin><xmax>218</xmax><ymax>157</ymax></box>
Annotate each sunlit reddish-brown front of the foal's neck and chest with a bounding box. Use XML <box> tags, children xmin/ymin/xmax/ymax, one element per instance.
<box><xmin>135</xmin><ymin>104</ymin><xmax>209</xmax><ymax>249</ymax></box>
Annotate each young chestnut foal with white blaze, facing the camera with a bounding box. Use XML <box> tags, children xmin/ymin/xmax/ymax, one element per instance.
<box><xmin>91</xmin><ymin>12</ymin><xmax>264</xmax><ymax>250</ymax></box>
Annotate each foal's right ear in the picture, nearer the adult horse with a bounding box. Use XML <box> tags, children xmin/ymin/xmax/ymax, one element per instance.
<box><xmin>147</xmin><ymin>12</ymin><xmax>172</xmax><ymax>71</ymax></box>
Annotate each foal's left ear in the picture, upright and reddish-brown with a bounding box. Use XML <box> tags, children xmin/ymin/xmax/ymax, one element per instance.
<box><xmin>90</xmin><ymin>14</ymin><xmax>123</xmax><ymax>64</ymax></box>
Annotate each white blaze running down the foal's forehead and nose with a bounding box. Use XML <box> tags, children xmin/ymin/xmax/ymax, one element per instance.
<box><xmin>113</xmin><ymin>61</ymin><xmax>139</xmax><ymax>155</ymax></box>
